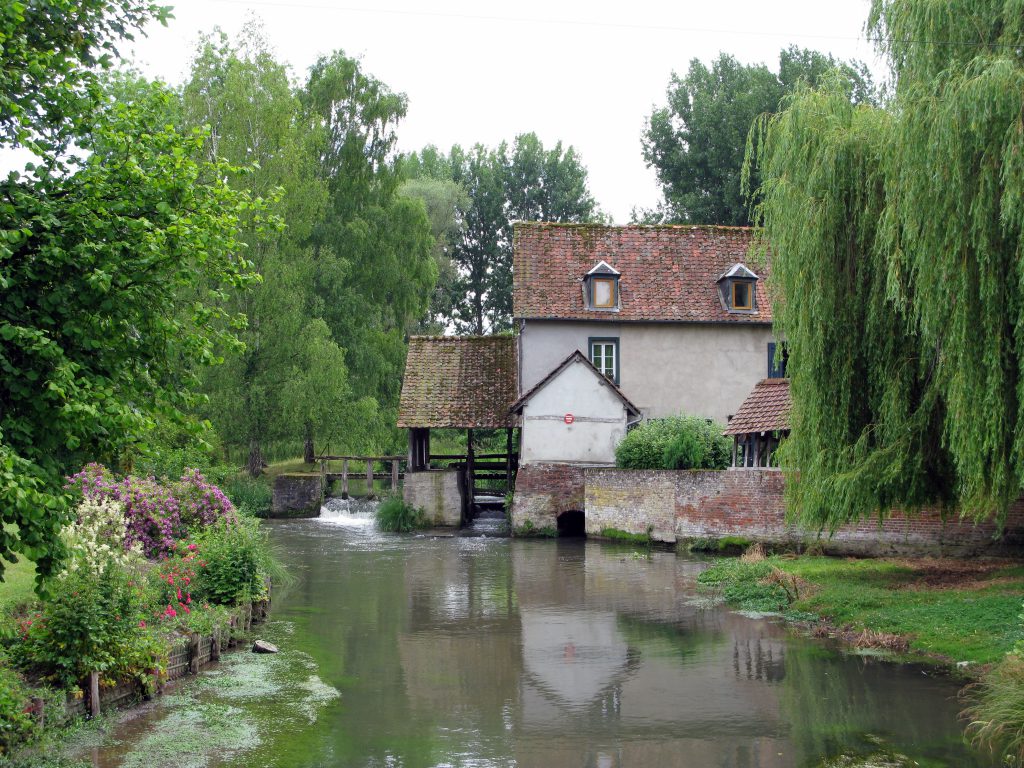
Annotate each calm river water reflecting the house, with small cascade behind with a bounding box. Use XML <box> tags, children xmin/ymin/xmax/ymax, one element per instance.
<box><xmin>85</xmin><ymin>508</ymin><xmax>993</xmax><ymax>768</ymax></box>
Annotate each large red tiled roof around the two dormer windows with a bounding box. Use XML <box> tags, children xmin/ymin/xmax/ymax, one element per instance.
<box><xmin>512</xmin><ymin>222</ymin><xmax>771</xmax><ymax>323</ymax></box>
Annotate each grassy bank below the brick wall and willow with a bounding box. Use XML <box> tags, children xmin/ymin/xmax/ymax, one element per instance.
<box><xmin>699</xmin><ymin>555</ymin><xmax>1024</xmax><ymax>664</ymax></box>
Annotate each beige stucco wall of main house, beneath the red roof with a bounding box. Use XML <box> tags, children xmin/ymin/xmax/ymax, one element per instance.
<box><xmin>519</xmin><ymin>321</ymin><xmax>773</xmax><ymax>424</ymax></box>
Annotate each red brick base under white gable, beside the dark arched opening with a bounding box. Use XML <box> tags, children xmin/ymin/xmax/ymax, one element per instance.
<box><xmin>512</xmin><ymin>464</ymin><xmax>584</xmax><ymax>534</ymax></box>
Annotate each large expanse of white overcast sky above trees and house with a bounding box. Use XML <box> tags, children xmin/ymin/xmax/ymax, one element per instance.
<box><xmin>121</xmin><ymin>0</ymin><xmax>881</xmax><ymax>223</ymax></box>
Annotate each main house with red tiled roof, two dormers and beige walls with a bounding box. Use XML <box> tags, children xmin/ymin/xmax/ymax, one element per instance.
<box><xmin>513</xmin><ymin>222</ymin><xmax>782</xmax><ymax>463</ymax></box>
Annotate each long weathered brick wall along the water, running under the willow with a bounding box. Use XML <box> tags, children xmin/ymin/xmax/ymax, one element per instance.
<box><xmin>513</xmin><ymin>464</ymin><xmax>1024</xmax><ymax>555</ymax></box>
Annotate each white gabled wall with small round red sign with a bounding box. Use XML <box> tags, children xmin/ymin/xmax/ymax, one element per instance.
<box><xmin>519</xmin><ymin>360</ymin><xmax>627</xmax><ymax>465</ymax></box>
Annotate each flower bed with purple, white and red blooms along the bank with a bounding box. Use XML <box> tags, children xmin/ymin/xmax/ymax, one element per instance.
<box><xmin>0</xmin><ymin>465</ymin><xmax>274</xmax><ymax>755</ymax></box>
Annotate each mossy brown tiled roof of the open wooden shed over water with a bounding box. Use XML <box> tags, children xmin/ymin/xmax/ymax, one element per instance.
<box><xmin>398</xmin><ymin>336</ymin><xmax>518</xmax><ymax>429</ymax></box>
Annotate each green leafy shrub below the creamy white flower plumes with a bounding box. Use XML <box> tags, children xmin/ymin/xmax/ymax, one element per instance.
<box><xmin>11</xmin><ymin>567</ymin><xmax>164</xmax><ymax>687</ymax></box>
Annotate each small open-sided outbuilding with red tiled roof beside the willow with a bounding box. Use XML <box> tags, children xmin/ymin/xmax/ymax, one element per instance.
<box><xmin>724</xmin><ymin>379</ymin><xmax>792</xmax><ymax>467</ymax></box>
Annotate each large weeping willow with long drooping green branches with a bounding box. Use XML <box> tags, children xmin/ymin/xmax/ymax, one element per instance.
<box><xmin>748</xmin><ymin>0</ymin><xmax>1024</xmax><ymax>527</ymax></box>
